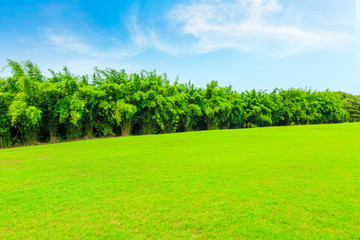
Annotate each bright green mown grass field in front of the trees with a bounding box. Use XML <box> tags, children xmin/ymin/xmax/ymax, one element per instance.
<box><xmin>0</xmin><ymin>124</ymin><xmax>360</xmax><ymax>239</ymax></box>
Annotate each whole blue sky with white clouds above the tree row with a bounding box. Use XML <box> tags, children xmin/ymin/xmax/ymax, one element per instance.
<box><xmin>0</xmin><ymin>0</ymin><xmax>360</xmax><ymax>94</ymax></box>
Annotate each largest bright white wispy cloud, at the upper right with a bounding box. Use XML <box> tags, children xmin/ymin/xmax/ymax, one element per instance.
<box><xmin>131</xmin><ymin>0</ymin><xmax>355</xmax><ymax>56</ymax></box>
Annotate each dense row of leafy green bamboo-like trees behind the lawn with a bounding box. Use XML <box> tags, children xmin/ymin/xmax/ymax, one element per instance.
<box><xmin>0</xmin><ymin>60</ymin><xmax>360</xmax><ymax>147</ymax></box>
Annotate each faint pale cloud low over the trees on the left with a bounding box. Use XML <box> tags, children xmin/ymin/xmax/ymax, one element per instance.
<box><xmin>28</xmin><ymin>28</ymin><xmax>141</xmax><ymax>74</ymax></box>
